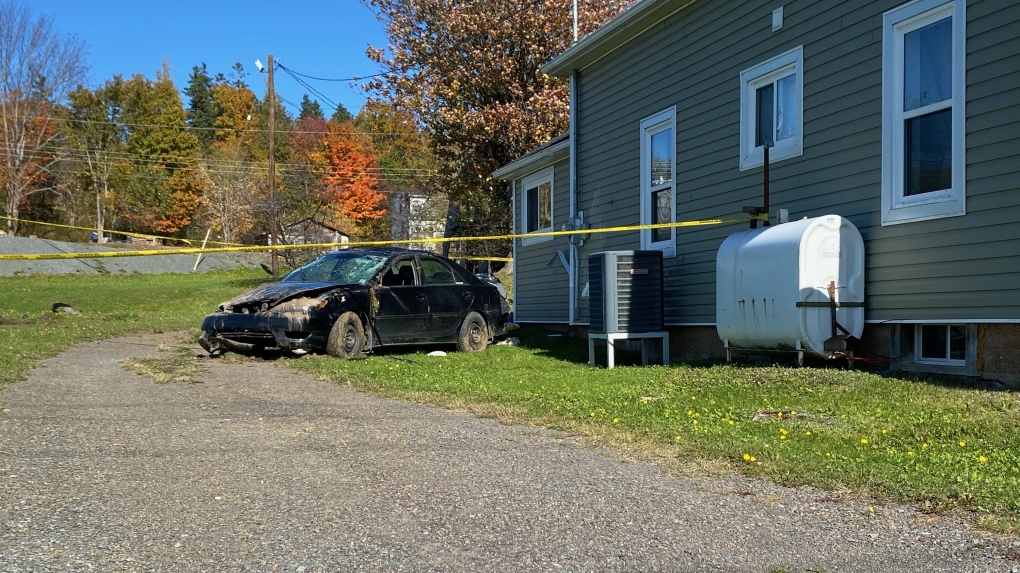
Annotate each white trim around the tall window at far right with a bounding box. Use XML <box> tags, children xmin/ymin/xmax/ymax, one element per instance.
<box><xmin>882</xmin><ymin>0</ymin><xmax>967</xmax><ymax>225</ymax></box>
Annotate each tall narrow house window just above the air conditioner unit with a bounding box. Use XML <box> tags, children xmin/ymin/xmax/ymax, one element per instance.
<box><xmin>641</xmin><ymin>108</ymin><xmax>676</xmax><ymax>257</ymax></box>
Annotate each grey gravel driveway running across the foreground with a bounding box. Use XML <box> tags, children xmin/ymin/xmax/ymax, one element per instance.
<box><xmin>0</xmin><ymin>335</ymin><xmax>1020</xmax><ymax>573</ymax></box>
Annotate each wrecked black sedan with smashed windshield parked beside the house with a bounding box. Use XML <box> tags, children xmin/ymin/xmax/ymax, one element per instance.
<box><xmin>199</xmin><ymin>250</ymin><xmax>510</xmax><ymax>358</ymax></box>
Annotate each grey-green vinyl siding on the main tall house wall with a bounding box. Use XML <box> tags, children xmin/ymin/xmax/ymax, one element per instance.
<box><xmin>575</xmin><ymin>0</ymin><xmax>1020</xmax><ymax>324</ymax></box>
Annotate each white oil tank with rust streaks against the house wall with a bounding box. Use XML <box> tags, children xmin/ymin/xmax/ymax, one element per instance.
<box><xmin>715</xmin><ymin>215</ymin><xmax>864</xmax><ymax>358</ymax></box>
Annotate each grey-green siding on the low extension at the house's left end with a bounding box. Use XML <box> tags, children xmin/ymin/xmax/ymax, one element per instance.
<box><xmin>514</xmin><ymin>159</ymin><xmax>570</xmax><ymax>323</ymax></box>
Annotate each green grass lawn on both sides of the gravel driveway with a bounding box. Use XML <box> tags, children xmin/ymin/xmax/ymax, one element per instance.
<box><xmin>0</xmin><ymin>270</ymin><xmax>1020</xmax><ymax>534</ymax></box>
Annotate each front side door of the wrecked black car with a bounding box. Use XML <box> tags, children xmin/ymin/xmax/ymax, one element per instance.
<box><xmin>374</xmin><ymin>257</ymin><xmax>428</xmax><ymax>345</ymax></box>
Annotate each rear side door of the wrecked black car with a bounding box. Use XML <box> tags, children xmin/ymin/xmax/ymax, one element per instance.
<box><xmin>420</xmin><ymin>256</ymin><xmax>474</xmax><ymax>342</ymax></box>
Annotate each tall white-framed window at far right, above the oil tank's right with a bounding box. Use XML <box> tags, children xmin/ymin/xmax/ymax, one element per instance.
<box><xmin>882</xmin><ymin>0</ymin><xmax>966</xmax><ymax>224</ymax></box>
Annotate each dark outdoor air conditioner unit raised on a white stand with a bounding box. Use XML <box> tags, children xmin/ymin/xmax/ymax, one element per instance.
<box><xmin>588</xmin><ymin>251</ymin><xmax>663</xmax><ymax>333</ymax></box>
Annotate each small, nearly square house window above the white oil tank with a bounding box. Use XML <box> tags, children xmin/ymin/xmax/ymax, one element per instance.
<box><xmin>741</xmin><ymin>46</ymin><xmax>804</xmax><ymax>170</ymax></box>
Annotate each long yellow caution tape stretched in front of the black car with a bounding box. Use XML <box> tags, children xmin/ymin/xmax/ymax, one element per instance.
<box><xmin>0</xmin><ymin>214</ymin><xmax>768</xmax><ymax>261</ymax></box>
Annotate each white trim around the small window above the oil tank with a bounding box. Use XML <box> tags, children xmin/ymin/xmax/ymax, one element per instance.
<box><xmin>741</xmin><ymin>46</ymin><xmax>804</xmax><ymax>171</ymax></box>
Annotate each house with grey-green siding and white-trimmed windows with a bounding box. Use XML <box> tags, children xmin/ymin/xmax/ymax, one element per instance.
<box><xmin>495</xmin><ymin>0</ymin><xmax>1020</xmax><ymax>383</ymax></box>
